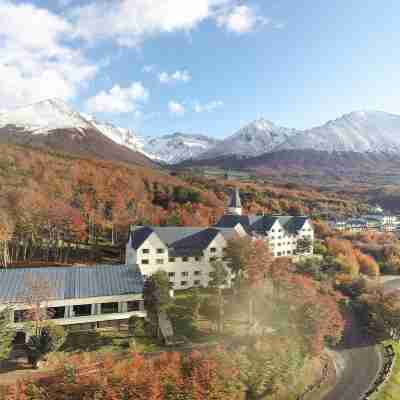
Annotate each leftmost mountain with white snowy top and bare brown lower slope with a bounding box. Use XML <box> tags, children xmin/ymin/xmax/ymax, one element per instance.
<box><xmin>0</xmin><ymin>100</ymin><xmax>155</xmax><ymax>166</ymax></box>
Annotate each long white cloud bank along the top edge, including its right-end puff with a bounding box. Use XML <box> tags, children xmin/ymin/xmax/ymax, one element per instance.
<box><xmin>69</xmin><ymin>0</ymin><xmax>265</xmax><ymax>47</ymax></box>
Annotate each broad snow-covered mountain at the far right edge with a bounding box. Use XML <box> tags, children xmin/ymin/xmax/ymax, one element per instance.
<box><xmin>274</xmin><ymin>111</ymin><xmax>400</xmax><ymax>153</ymax></box>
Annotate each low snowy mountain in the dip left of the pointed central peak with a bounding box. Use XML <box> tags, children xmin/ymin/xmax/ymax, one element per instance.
<box><xmin>143</xmin><ymin>132</ymin><xmax>218</xmax><ymax>164</ymax></box>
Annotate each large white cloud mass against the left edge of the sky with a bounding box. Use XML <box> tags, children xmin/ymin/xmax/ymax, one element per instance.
<box><xmin>0</xmin><ymin>0</ymin><xmax>99</xmax><ymax>109</ymax></box>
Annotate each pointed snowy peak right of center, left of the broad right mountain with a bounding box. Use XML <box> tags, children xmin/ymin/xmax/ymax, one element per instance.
<box><xmin>199</xmin><ymin>119</ymin><xmax>299</xmax><ymax>159</ymax></box>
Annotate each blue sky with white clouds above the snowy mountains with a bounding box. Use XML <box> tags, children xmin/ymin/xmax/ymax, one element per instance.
<box><xmin>0</xmin><ymin>0</ymin><xmax>400</xmax><ymax>137</ymax></box>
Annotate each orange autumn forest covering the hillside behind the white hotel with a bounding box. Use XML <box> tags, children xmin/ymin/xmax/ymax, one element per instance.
<box><xmin>0</xmin><ymin>144</ymin><xmax>367</xmax><ymax>265</ymax></box>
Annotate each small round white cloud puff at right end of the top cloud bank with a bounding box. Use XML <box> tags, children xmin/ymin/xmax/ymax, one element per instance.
<box><xmin>217</xmin><ymin>5</ymin><xmax>270</xmax><ymax>34</ymax></box>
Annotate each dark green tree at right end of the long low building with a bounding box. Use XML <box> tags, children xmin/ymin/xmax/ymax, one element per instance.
<box><xmin>143</xmin><ymin>270</ymin><xmax>171</xmax><ymax>337</ymax></box>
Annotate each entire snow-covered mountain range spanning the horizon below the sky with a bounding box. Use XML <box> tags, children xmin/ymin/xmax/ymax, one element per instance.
<box><xmin>0</xmin><ymin>99</ymin><xmax>400</xmax><ymax>165</ymax></box>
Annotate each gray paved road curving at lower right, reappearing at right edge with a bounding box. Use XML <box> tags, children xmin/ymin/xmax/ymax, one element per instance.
<box><xmin>323</xmin><ymin>278</ymin><xmax>400</xmax><ymax>400</ymax></box>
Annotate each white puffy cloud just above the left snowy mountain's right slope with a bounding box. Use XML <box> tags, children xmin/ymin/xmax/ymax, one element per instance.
<box><xmin>86</xmin><ymin>82</ymin><xmax>149</xmax><ymax>115</ymax></box>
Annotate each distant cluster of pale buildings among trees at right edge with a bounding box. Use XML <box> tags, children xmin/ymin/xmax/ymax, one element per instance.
<box><xmin>330</xmin><ymin>206</ymin><xmax>400</xmax><ymax>232</ymax></box>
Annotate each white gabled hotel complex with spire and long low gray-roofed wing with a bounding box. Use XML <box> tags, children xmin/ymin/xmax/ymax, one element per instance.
<box><xmin>0</xmin><ymin>189</ymin><xmax>314</xmax><ymax>340</ymax></box>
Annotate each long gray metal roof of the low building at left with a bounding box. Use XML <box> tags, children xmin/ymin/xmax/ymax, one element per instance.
<box><xmin>0</xmin><ymin>265</ymin><xmax>143</xmax><ymax>303</ymax></box>
